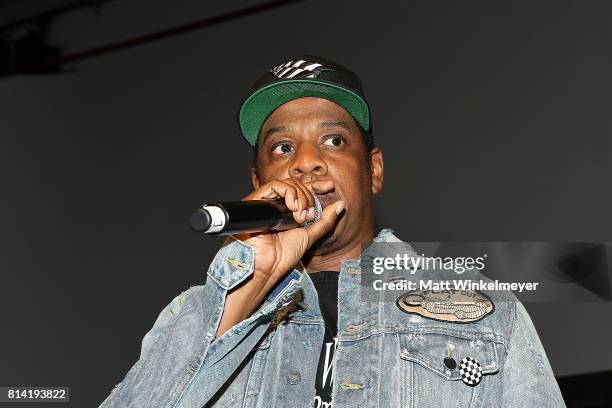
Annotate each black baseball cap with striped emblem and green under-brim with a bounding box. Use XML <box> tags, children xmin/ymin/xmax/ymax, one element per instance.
<box><xmin>238</xmin><ymin>55</ymin><xmax>371</xmax><ymax>146</ymax></box>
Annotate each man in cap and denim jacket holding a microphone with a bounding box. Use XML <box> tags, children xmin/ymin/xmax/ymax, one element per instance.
<box><xmin>102</xmin><ymin>55</ymin><xmax>564</xmax><ymax>407</ymax></box>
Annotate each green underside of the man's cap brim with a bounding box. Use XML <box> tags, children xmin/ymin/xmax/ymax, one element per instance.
<box><xmin>239</xmin><ymin>79</ymin><xmax>370</xmax><ymax>146</ymax></box>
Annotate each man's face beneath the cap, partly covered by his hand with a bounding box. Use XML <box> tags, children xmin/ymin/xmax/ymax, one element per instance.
<box><xmin>252</xmin><ymin>97</ymin><xmax>383</xmax><ymax>254</ymax></box>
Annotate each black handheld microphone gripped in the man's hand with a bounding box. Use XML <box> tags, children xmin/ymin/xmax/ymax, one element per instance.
<box><xmin>189</xmin><ymin>196</ymin><xmax>322</xmax><ymax>235</ymax></box>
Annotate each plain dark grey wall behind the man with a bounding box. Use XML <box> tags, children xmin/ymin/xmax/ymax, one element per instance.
<box><xmin>0</xmin><ymin>0</ymin><xmax>612</xmax><ymax>407</ymax></box>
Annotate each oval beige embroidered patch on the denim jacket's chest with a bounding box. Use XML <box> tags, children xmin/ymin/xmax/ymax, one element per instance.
<box><xmin>396</xmin><ymin>290</ymin><xmax>495</xmax><ymax>323</ymax></box>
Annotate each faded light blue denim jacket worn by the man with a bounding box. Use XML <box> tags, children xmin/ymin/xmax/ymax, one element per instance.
<box><xmin>101</xmin><ymin>230</ymin><xmax>565</xmax><ymax>408</ymax></box>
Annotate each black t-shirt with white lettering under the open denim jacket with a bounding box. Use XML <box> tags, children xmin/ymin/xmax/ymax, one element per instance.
<box><xmin>310</xmin><ymin>271</ymin><xmax>340</xmax><ymax>408</ymax></box>
